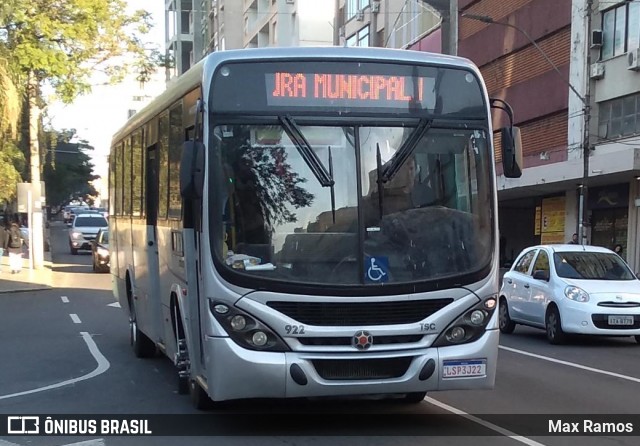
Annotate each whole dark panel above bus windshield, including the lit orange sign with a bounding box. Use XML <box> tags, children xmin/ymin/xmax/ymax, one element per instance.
<box><xmin>209</xmin><ymin>59</ymin><xmax>487</xmax><ymax>119</ymax></box>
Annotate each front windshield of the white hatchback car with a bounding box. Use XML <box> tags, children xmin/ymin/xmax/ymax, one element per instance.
<box><xmin>553</xmin><ymin>251</ymin><xmax>635</xmax><ymax>280</ymax></box>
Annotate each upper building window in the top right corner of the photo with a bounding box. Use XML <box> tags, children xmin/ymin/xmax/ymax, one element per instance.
<box><xmin>600</xmin><ymin>1</ymin><xmax>640</xmax><ymax>60</ymax></box>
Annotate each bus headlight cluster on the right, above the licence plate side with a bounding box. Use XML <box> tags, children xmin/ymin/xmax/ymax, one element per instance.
<box><xmin>433</xmin><ymin>296</ymin><xmax>498</xmax><ymax>347</ymax></box>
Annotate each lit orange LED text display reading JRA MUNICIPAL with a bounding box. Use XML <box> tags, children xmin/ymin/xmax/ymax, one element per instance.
<box><xmin>265</xmin><ymin>71</ymin><xmax>435</xmax><ymax>109</ymax></box>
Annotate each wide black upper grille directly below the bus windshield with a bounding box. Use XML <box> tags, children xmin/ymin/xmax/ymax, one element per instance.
<box><xmin>267</xmin><ymin>298</ymin><xmax>453</xmax><ymax>327</ymax></box>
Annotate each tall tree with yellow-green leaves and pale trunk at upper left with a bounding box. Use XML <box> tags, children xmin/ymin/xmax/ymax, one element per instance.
<box><xmin>0</xmin><ymin>0</ymin><xmax>156</xmax><ymax>183</ymax></box>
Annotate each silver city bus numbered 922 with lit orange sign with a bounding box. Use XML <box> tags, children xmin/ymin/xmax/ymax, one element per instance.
<box><xmin>109</xmin><ymin>47</ymin><xmax>522</xmax><ymax>408</ymax></box>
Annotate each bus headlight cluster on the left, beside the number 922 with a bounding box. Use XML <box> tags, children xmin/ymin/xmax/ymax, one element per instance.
<box><xmin>209</xmin><ymin>300</ymin><xmax>289</xmax><ymax>352</ymax></box>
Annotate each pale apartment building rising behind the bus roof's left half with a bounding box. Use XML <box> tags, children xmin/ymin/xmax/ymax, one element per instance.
<box><xmin>165</xmin><ymin>0</ymin><xmax>336</xmax><ymax>81</ymax></box>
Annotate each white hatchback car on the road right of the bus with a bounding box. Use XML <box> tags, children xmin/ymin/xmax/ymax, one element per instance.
<box><xmin>499</xmin><ymin>245</ymin><xmax>640</xmax><ymax>344</ymax></box>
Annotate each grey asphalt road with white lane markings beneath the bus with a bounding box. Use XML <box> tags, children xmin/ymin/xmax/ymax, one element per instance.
<box><xmin>0</xmin><ymin>224</ymin><xmax>640</xmax><ymax>446</ymax></box>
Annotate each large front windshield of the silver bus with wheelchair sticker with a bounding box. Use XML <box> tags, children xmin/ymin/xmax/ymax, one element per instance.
<box><xmin>209</xmin><ymin>121</ymin><xmax>493</xmax><ymax>286</ymax></box>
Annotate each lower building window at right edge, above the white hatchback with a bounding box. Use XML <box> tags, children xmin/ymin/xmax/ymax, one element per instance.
<box><xmin>598</xmin><ymin>93</ymin><xmax>640</xmax><ymax>140</ymax></box>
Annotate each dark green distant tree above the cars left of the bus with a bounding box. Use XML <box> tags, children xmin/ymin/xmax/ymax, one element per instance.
<box><xmin>42</xmin><ymin>130</ymin><xmax>98</xmax><ymax>206</ymax></box>
